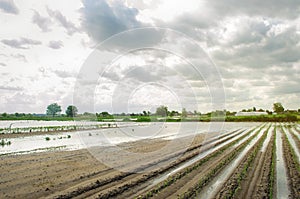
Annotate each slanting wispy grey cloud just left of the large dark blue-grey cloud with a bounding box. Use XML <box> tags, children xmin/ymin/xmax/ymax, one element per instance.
<box><xmin>47</xmin><ymin>7</ymin><xmax>79</xmax><ymax>35</ymax></box>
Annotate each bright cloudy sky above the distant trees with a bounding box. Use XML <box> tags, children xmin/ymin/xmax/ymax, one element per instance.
<box><xmin>0</xmin><ymin>0</ymin><xmax>300</xmax><ymax>113</ymax></box>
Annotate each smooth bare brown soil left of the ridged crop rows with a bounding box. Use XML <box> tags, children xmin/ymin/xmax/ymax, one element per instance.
<box><xmin>0</xmin><ymin>131</ymin><xmax>203</xmax><ymax>198</ymax></box>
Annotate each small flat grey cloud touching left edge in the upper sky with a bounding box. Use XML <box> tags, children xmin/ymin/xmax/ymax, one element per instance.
<box><xmin>1</xmin><ymin>37</ymin><xmax>42</xmax><ymax>49</ymax></box>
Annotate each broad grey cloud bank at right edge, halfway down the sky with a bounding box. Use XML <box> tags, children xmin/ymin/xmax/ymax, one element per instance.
<box><xmin>213</xmin><ymin>23</ymin><xmax>300</xmax><ymax>68</ymax></box>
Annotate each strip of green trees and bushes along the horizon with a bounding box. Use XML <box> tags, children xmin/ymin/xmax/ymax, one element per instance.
<box><xmin>0</xmin><ymin>102</ymin><xmax>300</xmax><ymax>121</ymax></box>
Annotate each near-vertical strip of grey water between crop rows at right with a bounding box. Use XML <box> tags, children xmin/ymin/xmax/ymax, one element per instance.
<box><xmin>276</xmin><ymin>128</ymin><xmax>290</xmax><ymax>199</ymax></box>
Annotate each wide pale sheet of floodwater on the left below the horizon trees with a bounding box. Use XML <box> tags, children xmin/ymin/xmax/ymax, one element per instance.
<box><xmin>0</xmin><ymin>121</ymin><xmax>259</xmax><ymax>154</ymax></box>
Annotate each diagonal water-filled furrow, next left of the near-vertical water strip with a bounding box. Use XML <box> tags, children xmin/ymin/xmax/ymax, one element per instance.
<box><xmin>198</xmin><ymin>124</ymin><xmax>266</xmax><ymax>199</ymax></box>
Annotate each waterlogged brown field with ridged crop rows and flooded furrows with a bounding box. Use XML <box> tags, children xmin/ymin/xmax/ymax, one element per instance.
<box><xmin>0</xmin><ymin>122</ymin><xmax>300</xmax><ymax>199</ymax></box>
